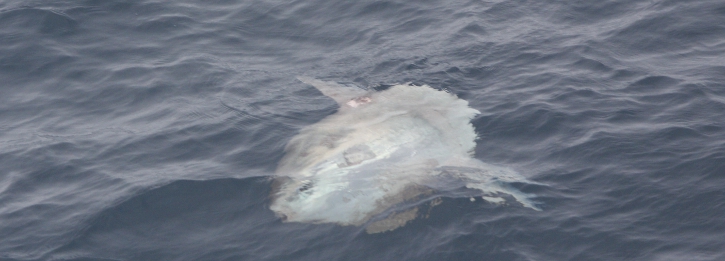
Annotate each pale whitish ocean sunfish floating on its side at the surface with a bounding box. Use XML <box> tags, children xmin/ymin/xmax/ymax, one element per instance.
<box><xmin>270</xmin><ymin>77</ymin><xmax>540</xmax><ymax>233</ymax></box>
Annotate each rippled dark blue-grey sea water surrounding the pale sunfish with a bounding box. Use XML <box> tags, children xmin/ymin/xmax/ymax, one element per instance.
<box><xmin>0</xmin><ymin>0</ymin><xmax>725</xmax><ymax>261</ymax></box>
